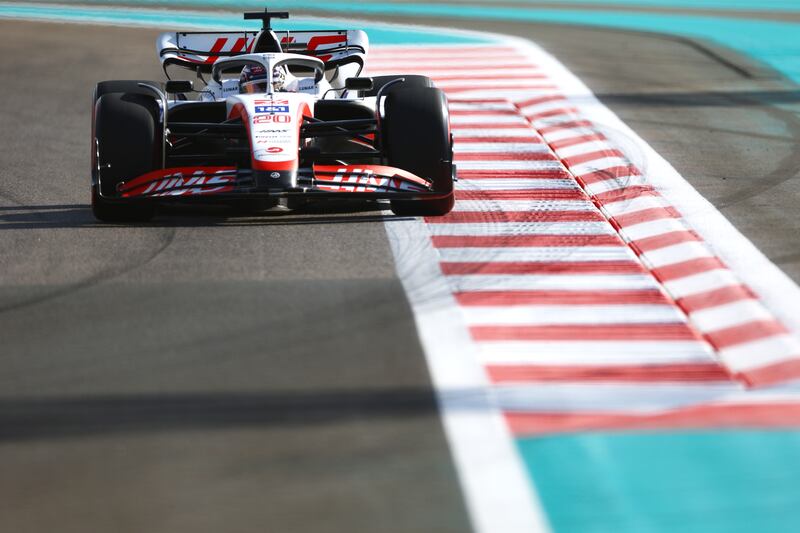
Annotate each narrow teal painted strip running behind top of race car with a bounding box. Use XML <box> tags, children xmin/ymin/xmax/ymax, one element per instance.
<box><xmin>0</xmin><ymin>3</ymin><xmax>495</xmax><ymax>44</ymax></box>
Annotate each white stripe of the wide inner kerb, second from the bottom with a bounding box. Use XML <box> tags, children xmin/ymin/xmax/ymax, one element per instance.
<box><xmin>478</xmin><ymin>341</ymin><xmax>717</xmax><ymax>365</ymax></box>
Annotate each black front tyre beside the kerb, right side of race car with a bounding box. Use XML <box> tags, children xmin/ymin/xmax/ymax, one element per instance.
<box><xmin>382</xmin><ymin>87</ymin><xmax>455</xmax><ymax>216</ymax></box>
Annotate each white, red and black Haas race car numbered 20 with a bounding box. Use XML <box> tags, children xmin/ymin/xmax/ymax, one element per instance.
<box><xmin>92</xmin><ymin>10</ymin><xmax>455</xmax><ymax>222</ymax></box>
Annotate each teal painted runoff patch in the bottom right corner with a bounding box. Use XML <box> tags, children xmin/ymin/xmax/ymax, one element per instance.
<box><xmin>518</xmin><ymin>430</ymin><xmax>800</xmax><ymax>533</ymax></box>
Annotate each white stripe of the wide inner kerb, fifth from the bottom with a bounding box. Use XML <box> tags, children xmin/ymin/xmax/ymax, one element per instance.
<box><xmin>439</xmin><ymin>244</ymin><xmax>635</xmax><ymax>264</ymax></box>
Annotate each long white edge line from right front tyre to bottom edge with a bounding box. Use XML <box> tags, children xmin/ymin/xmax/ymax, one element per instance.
<box><xmin>385</xmin><ymin>214</ymin><xmax>549</xmax><ymax>533</ymax></box>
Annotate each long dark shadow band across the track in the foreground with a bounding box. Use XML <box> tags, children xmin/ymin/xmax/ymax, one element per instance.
<box><xmin>0</xmin><ymin>387</ymin><xmax>486</xmax><ymax>442</ymax></box>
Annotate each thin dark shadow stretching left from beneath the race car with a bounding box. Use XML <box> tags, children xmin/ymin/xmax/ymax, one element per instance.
<box><xmin>0</xmin><ymin>203</ymin><xmax>403</xmax><ymax>230</ymax></box>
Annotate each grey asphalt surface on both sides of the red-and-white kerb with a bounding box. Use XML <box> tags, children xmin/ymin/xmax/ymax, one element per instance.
<box><xmin>0</xmin><ymin>7</ymin><xmax>800</xmax><ymax>532</ymax></box>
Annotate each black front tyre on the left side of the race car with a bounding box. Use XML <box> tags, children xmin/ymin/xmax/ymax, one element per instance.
<box><xmin>92</xmin><ymin>92</ymin><xmax>161</xmax><ymax>222</ymax></box>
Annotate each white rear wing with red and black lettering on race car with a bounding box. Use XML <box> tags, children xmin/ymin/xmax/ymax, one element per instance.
<box><xmin>156</xmin><ymin>30</ymin><xmax>369</xmax><ymax>77</ymax></box>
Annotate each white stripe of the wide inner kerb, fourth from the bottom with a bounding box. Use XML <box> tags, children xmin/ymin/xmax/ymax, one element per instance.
<box><xmin>440</xmin><ymin>274</ymin><xmax>658</xmax><ymax>292</ymax></box>
